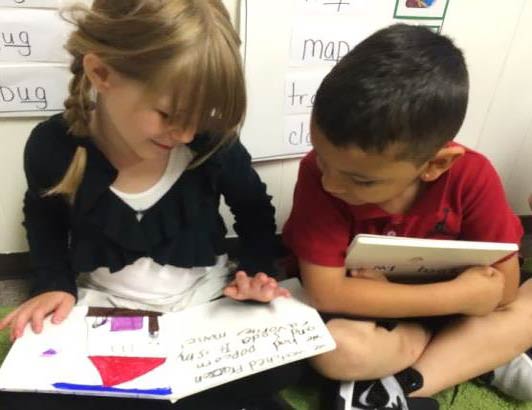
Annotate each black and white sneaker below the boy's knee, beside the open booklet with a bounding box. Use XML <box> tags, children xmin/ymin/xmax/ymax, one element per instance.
<box><xmin>335</xmin><ymin>368</ymin><xmax>439</xmax><ymax>410</ymax></box>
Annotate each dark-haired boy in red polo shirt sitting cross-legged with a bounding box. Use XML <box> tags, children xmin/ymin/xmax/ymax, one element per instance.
<box><xmin>283</xmin><ymin>25</ymin><xmax>532</xmax><ymax>409</ymax></box>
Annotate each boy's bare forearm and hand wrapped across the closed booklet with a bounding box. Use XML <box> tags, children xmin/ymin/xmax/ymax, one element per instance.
<box><xmin>299</xmin><ymin>260</ymin><xmax>502</xmax><ymax>318</ymax></box>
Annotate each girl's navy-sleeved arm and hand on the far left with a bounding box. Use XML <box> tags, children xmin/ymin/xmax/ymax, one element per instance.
<box><xmin>0</xmin><ymin>125</ymin><xmax>76</xmax><ymax>340</ymax></box>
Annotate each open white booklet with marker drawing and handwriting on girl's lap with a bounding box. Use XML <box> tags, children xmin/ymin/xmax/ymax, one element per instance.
<box><xmin>0</xmin><ymin>279</ymin><xmax>335</xmax><ymax>401</ymax></box>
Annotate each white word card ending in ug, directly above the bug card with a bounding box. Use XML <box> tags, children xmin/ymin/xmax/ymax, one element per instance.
<box><xmin>0</xmin><ymin>8</ymin><xmax>72</xmax><ymax>62</ymax></box>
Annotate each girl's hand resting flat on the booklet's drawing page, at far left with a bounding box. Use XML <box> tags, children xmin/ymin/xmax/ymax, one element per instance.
<box><xmin>0</xmin><ymin>291</ymin><xmax>76</xmax><ymax>342</ymax></box>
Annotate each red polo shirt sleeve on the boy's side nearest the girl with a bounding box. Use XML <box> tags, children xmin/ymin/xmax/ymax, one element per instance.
<box><xmin>283</xmin><ymin>152</ymin><xmax>351</xmax><ymax>267</ymax></box>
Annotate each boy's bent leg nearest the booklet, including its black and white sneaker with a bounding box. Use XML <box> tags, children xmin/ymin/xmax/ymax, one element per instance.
<box><xmin>311</xmin><ymin>319</ymin><xmax>437</xmax><ymax>410</ymax></box>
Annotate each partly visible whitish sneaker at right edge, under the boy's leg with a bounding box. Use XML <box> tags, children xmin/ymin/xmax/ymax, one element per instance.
<box><xmin>481</xmin><ymin>349</ymin><xmax>532</xmax><ymax>401</ymax></box>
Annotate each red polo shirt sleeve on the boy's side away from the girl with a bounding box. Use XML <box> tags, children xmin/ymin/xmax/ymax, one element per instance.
<box><xmin>461</xmin><ymin>155</ymin><xmax>523</xmax><ymax>244</ymax></box>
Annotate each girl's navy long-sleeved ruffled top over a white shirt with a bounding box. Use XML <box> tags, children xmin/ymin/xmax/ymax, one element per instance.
<box><xmin>24</xmin><ymin>114</ymin><xmax>279</xmax><ymax>295</ymax></box>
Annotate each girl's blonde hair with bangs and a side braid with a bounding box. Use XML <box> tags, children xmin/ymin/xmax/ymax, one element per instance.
<box><xmin>46</xmin><ymin>0</ymin><xmax>246</xmax><ymax>202</ymax></box>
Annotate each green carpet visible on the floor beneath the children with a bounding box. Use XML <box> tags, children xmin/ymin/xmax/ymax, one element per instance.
<box><xmin>0</xmin><ymin>307</ymin><xmax>532</xmax><ymax>410</ymax></box>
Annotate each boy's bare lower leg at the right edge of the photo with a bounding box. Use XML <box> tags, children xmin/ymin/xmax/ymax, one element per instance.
<box><xmin>412</xmin><ymin>280</ymin><xmax>532</xmax><ymax>396</ymax></box>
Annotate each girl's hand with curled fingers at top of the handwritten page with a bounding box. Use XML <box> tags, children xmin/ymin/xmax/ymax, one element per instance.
<box><xmin>224</xmin><ymin>271</ymin><xmax>290</xmax><ymax>302</ymax></box>
